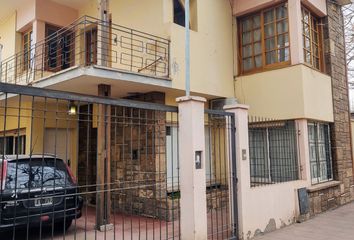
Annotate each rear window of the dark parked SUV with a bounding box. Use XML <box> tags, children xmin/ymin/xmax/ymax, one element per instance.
<box><xmin>5</xmin><ymin>158</ymin><xmax>72</xmax><ymax>189</ymax></box>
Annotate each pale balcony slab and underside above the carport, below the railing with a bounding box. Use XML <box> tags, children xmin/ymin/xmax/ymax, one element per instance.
<box><xmin>32</xmin><ymin>66</ymin><xmax>172</xmax><ymax>98</ymax></box>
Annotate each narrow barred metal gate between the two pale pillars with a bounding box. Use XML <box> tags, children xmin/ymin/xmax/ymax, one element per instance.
<box><xmin>205</xmin><ymin>110</ymin><xmax>238</xmax><ymax>239</ymax></box>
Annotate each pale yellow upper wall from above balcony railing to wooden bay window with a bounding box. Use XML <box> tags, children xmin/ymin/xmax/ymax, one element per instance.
<box><xmin>110</xmin><ymin>0</ymin><xmax>234</xmax><ymax>97</ymax></box>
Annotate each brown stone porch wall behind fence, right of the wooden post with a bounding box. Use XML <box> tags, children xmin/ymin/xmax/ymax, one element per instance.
<box><xmin>111</xmin><ymin>92</ymin><xmax>172</xmax><ymax>219</ymax></box>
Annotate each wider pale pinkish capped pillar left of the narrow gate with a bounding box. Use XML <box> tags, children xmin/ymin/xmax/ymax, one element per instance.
<box><xmin>176</xmin><ymin>96</ymin><xmax>207</xmax><ymax>240</ymax></box>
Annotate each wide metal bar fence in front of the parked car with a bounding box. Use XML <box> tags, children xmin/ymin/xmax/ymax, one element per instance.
<box><xmin>0</xmin><ymin>83</ymin><xmax>178</xmax><ymax>239</ymax></box>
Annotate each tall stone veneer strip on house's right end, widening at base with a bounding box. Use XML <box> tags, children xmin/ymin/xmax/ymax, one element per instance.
<box><xmin>309</xmin><ymin>0</ymin><xmax>353</xmax><ymax>215</ymax></box>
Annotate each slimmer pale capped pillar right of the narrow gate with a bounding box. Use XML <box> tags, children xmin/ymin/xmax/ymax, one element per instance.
<box><xmin>224</xmin><ymin>104</ymin><xmax>251</xmax><ymax>239</ymax></box>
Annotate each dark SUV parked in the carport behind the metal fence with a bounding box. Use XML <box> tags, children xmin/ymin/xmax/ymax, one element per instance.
<box><xmin>0</xmin><ymin>155</ymin><xmax>83</xmax><ymax>231</ymax></box>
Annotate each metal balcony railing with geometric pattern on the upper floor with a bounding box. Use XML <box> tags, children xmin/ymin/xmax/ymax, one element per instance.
<box><xmin>0</xmin><ymin>16</ymin><xmax>170</xmax><ymax>84</ymax></box>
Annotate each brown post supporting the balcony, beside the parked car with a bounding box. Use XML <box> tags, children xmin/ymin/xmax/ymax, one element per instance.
<box><xmin>96</xmin><ymin>84</ymin><xmax>113</xmax><ymax>231</ymax></box>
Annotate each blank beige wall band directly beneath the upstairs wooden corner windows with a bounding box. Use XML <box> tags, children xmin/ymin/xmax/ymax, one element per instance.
<box><xmin>235</xmin><ymin>64</ymin><xmax>333</xmax><ymax>122</ymax></box>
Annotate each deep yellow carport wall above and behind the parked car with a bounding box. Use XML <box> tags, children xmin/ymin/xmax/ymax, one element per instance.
<box><xmin>0</xmin><ymin>97</ymin><xmax>78</xmax><ymax>177</ymax></box>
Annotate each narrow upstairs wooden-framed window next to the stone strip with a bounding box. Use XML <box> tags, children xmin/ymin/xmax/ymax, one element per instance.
<box><xmin>302</xmin><ymin>7</ymin><xmax>323</xmax><ymax>70</ymax></box>
